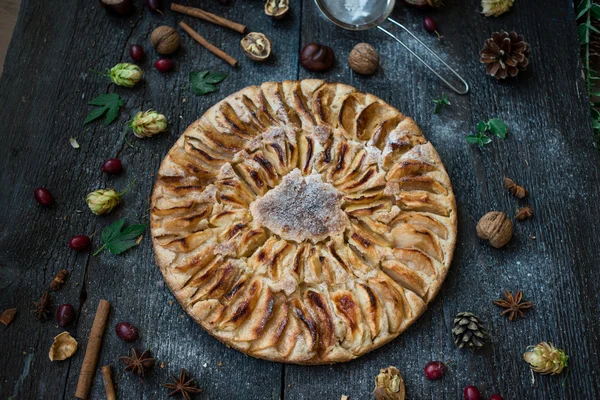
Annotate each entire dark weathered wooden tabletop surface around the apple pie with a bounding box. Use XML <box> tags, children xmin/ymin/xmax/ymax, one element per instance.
<box><xmin>0</xmin><ymin>0</ymin><xmax>600</xmax><ymax>400</ymax></box>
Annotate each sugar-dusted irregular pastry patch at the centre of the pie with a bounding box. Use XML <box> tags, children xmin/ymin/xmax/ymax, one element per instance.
<box><xmin>250</xmin><ymin>169</ymin><xmax>348</xmax><ymax>243</ymax></box>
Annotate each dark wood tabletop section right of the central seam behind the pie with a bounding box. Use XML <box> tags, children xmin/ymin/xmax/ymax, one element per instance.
<box><xmin>286</xmin><ymin>0</ymin><xmax>600</xmax><ymax>399</ymax></box>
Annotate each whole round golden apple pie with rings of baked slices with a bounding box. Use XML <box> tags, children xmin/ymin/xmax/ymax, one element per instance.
<box><xmin>151</xmin><ymin>79</ymin><xmax>456</xmax><ymax>364</ymax></box>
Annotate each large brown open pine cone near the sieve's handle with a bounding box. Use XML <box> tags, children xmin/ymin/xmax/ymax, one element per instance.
<box><xmin>479</xmin><ymin>32</ymin><xmax>531</xmax><ymax>79</ymax></box>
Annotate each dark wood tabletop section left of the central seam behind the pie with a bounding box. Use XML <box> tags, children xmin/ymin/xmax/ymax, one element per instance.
<box><xmin>0</xmin><ymin>1</ymin><xmax>299</xmax><ymax>399</ymax></box>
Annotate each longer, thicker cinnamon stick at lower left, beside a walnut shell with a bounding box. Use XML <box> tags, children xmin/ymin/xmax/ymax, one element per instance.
<box><xmin>75</xmin><ymin>300</ymin><xmax>110</xmax><ymax>399</ymax></box>
